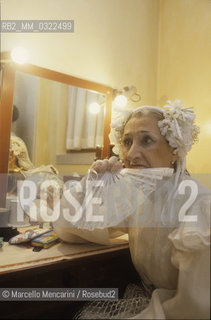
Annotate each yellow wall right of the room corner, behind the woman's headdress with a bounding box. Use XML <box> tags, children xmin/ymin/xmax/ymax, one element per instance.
<box><xmin>157</xmin><ymin>0</ymin><xmax>211</xmax><ymax>180</ymax></box>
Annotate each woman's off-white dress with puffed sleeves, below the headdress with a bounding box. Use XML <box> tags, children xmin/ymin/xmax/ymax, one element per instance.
<box><xmin>54</xmin><ymin>176</ymin><xmax>211</xmax><ymax>319</ymax></box>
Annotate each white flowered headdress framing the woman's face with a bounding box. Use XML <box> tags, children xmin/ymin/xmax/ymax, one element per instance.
<box><xmin>109</xmin><ymin>100</ymin><xmax>199</xmax><ymax>163</ymax></box>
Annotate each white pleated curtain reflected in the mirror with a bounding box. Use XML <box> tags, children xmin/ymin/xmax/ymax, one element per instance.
<box><xmin>66</xmin><ymin>86</ymin><xmax>104</xmax><ymax>150</ymax></box>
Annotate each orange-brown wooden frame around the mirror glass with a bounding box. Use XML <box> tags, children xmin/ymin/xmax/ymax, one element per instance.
<box><xmin>0</xmin><ymin>53</ymin><xmax>113</xmax><ymax>208</ymax></box>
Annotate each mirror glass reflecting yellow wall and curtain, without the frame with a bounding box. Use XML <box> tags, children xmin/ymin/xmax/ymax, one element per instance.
<box><xmin>12</xmin><ymin>72</ymin><xmax>106</xmax><ymax>166</ymax></box>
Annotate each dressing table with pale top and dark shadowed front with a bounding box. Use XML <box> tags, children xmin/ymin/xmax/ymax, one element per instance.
<box><xmin>0</xmin><ymin>238</ymin><xmax>139</xmax><ymax>319</ymax></box>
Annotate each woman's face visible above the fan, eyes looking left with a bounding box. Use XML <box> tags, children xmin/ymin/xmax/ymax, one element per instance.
<box><xmin>122</xmin><ymin>116</ymin><xmax>177</xmax><ymax>168</ymax></box>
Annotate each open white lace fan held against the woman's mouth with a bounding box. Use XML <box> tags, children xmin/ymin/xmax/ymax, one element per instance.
<box><xmin>67</xmin><ymin>168</ymin><xmax>173</xmax><ymax>230</ymax></box>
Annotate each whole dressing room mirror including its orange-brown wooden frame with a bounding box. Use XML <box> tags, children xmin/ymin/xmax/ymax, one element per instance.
<box><xmin>0</xmin><ymin>61</ymin><xmax>112</xmax><ymax>207</ymax></box>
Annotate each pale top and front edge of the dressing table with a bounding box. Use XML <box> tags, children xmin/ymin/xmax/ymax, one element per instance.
<box><xmin>0</xmin><ymin>235</ymin><xmax>129</xmax><ymax>275</ymax></box>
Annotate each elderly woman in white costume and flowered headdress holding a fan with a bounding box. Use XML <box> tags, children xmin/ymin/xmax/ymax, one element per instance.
<box><xmin>54</xmin><ymin>101</ymin><xmax>211</xmax><ymax>319</ymax></box>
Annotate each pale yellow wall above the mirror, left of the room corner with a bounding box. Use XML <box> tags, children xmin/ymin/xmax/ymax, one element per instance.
<box><xmin>1</xmin><ymin>0</ymin><xmax>159</xmax><ymax>173</ymax></box>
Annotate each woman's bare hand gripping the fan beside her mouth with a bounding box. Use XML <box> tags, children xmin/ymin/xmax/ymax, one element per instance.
<box><xmin>90</xmin><ymin>157</ymin><xmax>123</xmax><ymax>173</ymax></box>
